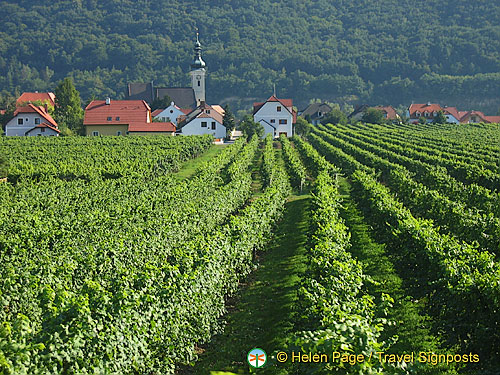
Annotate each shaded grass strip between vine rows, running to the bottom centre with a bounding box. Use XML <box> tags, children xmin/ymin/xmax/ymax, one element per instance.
<box><xmin>180</xmin><ymin>195</ymin><xmax>310</xmax><ymax>375</ymax></box>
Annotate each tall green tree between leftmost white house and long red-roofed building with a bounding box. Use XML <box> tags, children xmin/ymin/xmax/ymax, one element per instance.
<box><xmin>54</xmin><ymin>77</ymin><xmax>83</xmax><ymax>134</ymax></box>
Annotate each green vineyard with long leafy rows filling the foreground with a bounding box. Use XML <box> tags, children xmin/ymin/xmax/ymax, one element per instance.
<box><xmin>0</xmin><ymin>124</ymin><xmax>500</xmax><ymax>375</ymax></box>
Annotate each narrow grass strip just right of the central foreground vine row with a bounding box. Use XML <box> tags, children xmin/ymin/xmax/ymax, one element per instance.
<box><xmin>339</xmin><ymin>178</ymin><xmax>456</xmax><ymax>375</ymax></box>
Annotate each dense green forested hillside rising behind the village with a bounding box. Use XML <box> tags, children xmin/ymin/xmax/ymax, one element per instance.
<box><xmin>0</xmin><ymin>0</ymin><xmax>500</xmax><ymax>113</ymax></box>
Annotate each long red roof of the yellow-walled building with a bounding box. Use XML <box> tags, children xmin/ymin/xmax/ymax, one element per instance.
<box><xmin>83</xmin><ymin>100</ymin><xmax>151</xmax><ymax>125</ymax></box>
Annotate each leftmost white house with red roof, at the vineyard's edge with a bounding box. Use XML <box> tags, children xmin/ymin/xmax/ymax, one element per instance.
<box><xmin>5</xmin><ymin>104</ymin><xmax>60</xmax><ymax>137</ymax></box>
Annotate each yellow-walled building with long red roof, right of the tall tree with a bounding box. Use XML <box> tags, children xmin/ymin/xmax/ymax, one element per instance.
<box><xmin>83</xmin><ymin>98</ymin><xmax>151</xmax><ymax>136</ymax></box>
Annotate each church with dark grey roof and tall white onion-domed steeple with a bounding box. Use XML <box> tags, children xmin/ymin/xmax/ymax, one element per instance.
<box><xmin>126</xmin><ymin>33</ymin><xmax>206</xmax><ymax>110</ymax></box>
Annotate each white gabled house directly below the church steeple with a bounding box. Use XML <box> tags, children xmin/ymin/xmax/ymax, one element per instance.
<box><xmin>177</xmin><ymin>102</ymin><xmax>226</xmax><ymax>138</ymax></box>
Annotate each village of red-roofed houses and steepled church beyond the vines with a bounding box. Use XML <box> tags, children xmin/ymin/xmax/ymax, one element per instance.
<box><xmin>0</xmin><ymin>36</ymin><xmax>500</xmax><ymax>142</ymax></box>
